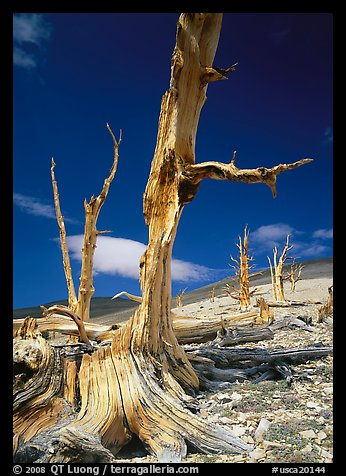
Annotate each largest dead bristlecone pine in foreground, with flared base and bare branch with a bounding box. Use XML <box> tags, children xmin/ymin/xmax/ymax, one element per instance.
<box><xmin>14</xmin><ymin>13</ymin><xmax>312</xmax><ymax>463</ymax></box>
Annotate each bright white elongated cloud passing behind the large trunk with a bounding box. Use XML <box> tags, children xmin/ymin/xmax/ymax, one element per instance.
<box><xmin>67</xmin><ymin>235</ymin><xmax>219</xmax><ymax>282</ymax></box>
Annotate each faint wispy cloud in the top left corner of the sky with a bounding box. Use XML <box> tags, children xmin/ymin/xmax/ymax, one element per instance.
<box><xmin>13</xmin><ymin>13</ymin><xmax>52</xmax><ymax>69</ymax></box>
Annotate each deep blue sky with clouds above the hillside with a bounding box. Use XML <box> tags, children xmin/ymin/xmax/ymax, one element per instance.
<box><xmin>13</xmin><ymin>12</ymin><xmax>333</xmax><ymax>308</ymax></box>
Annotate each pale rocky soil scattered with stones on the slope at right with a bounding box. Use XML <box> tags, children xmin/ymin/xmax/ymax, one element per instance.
<box><xmin>113</xmin><ymin>277</ymin><xmax>333</xmax><ymax>464</ymax></box>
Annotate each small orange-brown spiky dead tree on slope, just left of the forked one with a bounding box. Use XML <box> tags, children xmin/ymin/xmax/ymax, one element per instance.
<box><xmin>224</xmin><ymin>226</ymin><xmax>262</xmax><ymax>311</ymax></box>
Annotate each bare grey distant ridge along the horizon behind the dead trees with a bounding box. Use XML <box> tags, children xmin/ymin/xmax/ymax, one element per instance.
<box><xmin>13</xmin><ymin>258</ymin><xmax>333</xmax><ymax>325</ymax></box>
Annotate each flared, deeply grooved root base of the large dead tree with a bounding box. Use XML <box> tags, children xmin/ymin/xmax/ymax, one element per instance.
<box><xmin>14</xmin><ymin>319</ymin><xmax>251</xmax><ymax>463</ymax></box>
